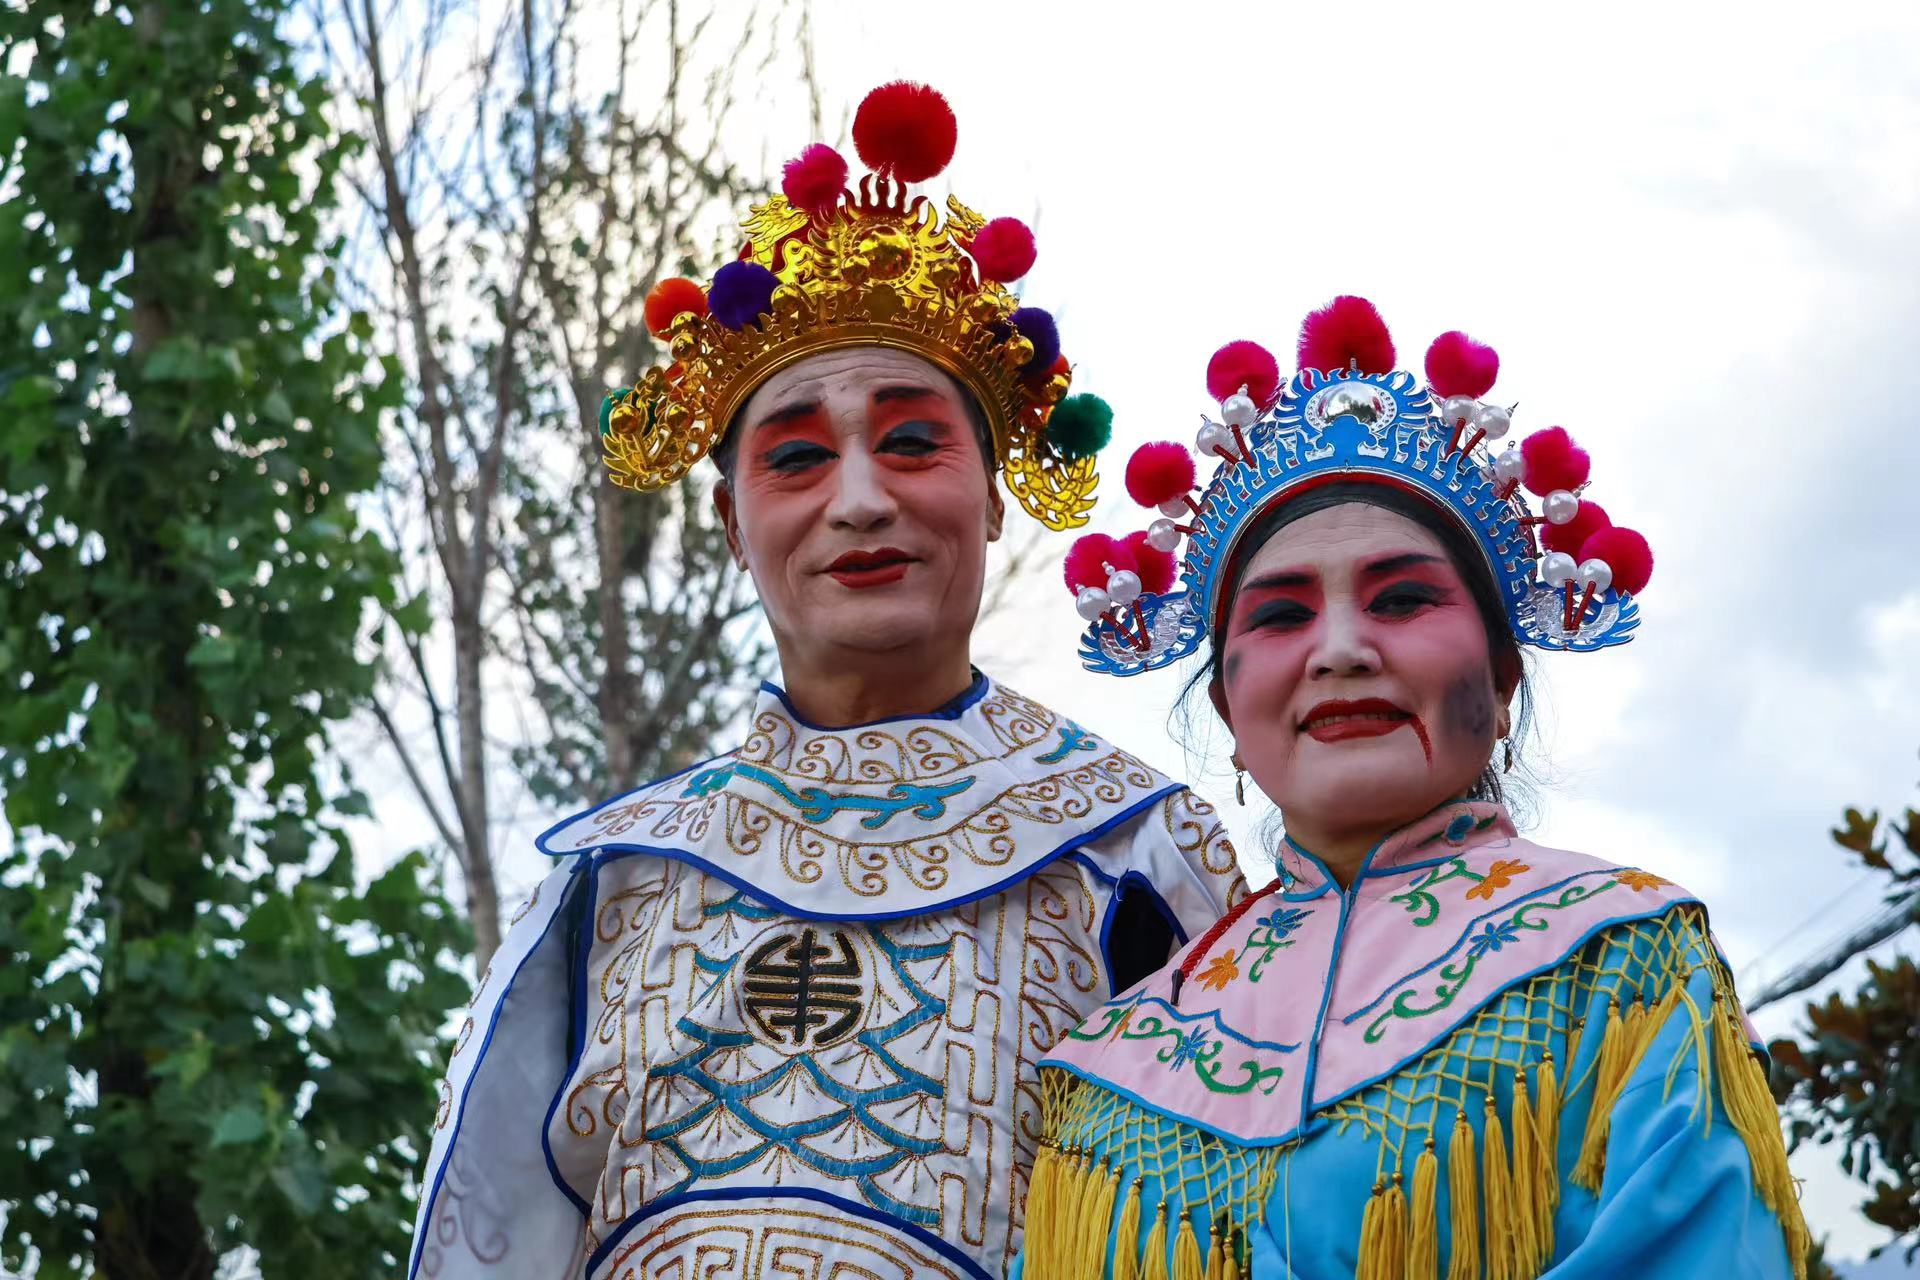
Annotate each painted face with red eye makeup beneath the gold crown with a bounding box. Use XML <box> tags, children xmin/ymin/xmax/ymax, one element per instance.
<box><xmin>714</xmin><ymin>347</ymin><xmax>1004</xmax><ymax>662</ymax></box>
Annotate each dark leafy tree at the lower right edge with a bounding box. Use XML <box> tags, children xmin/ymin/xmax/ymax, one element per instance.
<box><xmin>1770</xmin><ymin>786</ymin><xmax>1920</xmax><ymax>1249</ymax></box>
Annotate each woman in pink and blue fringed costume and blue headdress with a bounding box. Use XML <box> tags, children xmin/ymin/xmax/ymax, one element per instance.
<box><xmin>1023</xmin><ymin>297</ymin><xmax>1807</xmax><ymax>1280</ymax></box>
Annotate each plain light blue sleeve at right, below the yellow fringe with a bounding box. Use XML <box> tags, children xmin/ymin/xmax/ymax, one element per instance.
<box><xmin>1544</xmin><ymin>971</ymin><xmax>1793</xmax><ymax>1280</ymax></box>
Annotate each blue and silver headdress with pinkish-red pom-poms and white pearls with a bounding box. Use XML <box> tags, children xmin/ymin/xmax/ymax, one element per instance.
<box><xmin>1066</xmin><ymin>297</ymin><xmax>1653</xmax><ymax>676</ymax></box>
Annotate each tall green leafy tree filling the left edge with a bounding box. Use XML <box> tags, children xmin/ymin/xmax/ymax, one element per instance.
<box><xmin>0</xmin><ymin>0</ymin><xmax>467</xmax><ymax>1280</ymax></box>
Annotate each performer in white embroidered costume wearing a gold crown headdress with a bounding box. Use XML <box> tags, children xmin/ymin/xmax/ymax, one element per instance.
<box><xmin>411</xmin><ymin>84</ymin><xmax>1244</xmax><ymax>1280</ymax></box>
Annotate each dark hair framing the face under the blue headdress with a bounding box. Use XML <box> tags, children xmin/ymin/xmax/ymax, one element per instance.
<box><xmin>1181</xmin><ymin>480</ymin><xmax>1534</xmax><ymax>804</ymax></box>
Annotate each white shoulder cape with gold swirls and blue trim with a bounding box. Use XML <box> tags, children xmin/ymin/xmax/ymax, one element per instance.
<box><xmin>538</xmin><ymin>676</ymin><xmax>1183</xmax><ymax>919</ymax></box>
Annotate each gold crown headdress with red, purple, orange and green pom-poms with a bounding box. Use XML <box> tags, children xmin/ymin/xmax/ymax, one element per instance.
<box><xmin>601</xmin><ymin>83</ymin><xmax>1112</xmax><ymax>530</ymax></box>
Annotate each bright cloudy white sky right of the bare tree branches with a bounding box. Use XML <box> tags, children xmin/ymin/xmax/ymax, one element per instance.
<box><xmin>362</xmin><ymin>0</ymin><xmax>1920</xmax><ymax>1255</ymax></box>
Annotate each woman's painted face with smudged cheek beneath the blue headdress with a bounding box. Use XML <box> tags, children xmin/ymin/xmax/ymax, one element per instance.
<box><xmin>1212</xmin><ymin>503</ymin><xmax>1513</xmax><ymax>852</ymax></box>
